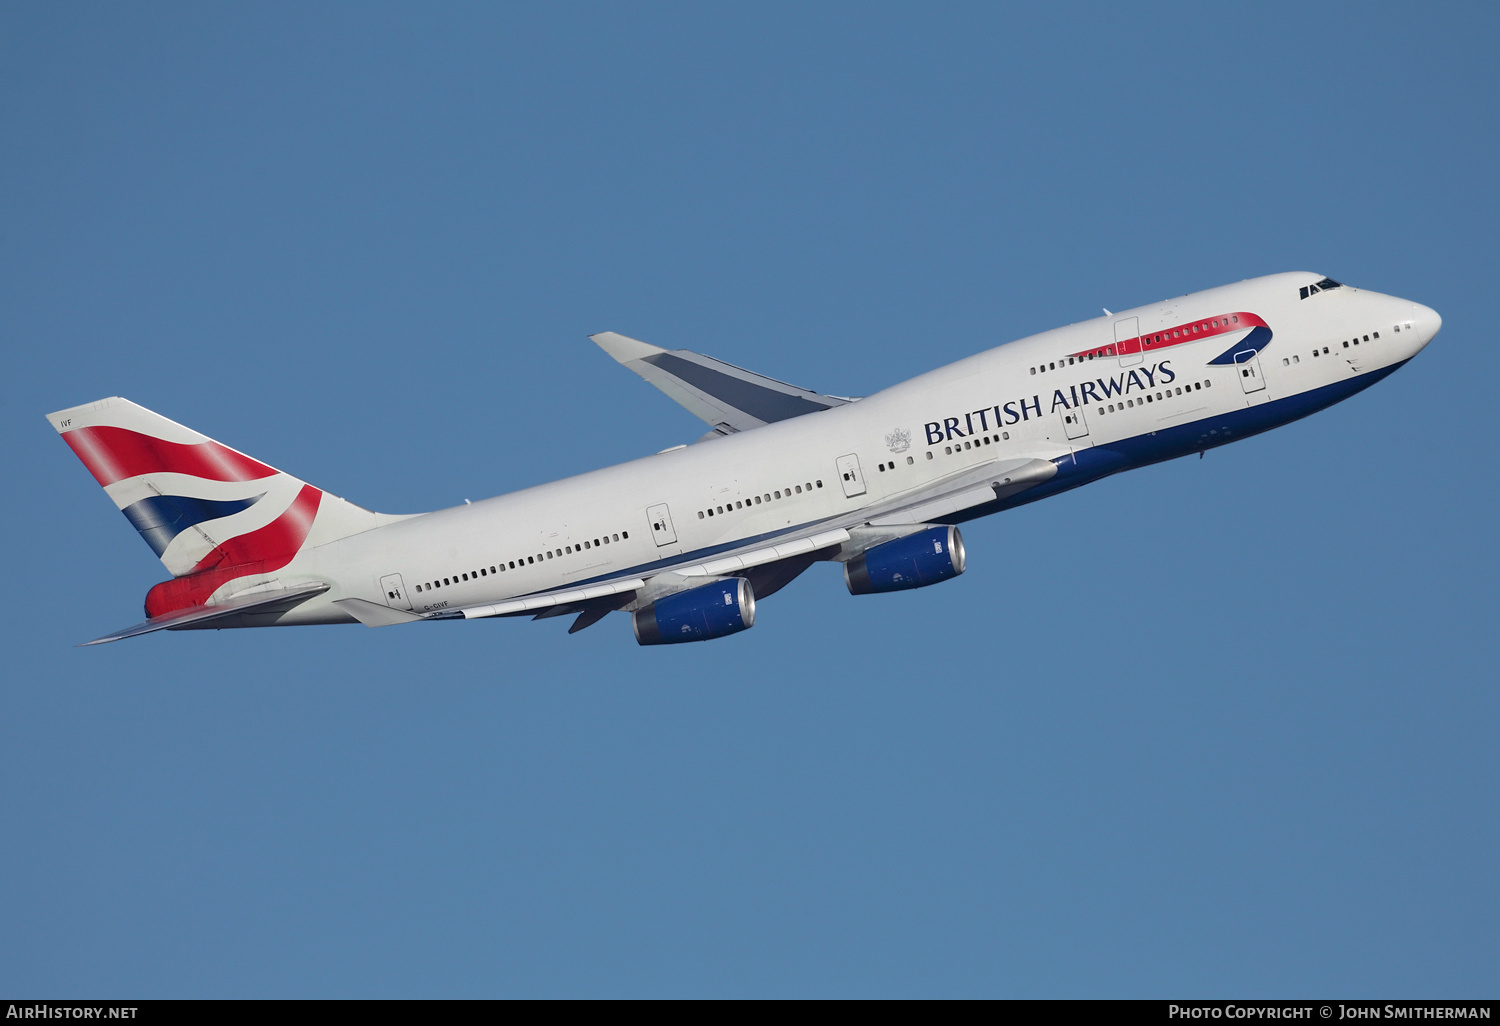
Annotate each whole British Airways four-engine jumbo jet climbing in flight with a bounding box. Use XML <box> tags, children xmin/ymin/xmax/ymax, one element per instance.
<box><xmin>48</xmin><ymin>272</ymin><xmax>1442</xmax><ymax>645</ymax></box>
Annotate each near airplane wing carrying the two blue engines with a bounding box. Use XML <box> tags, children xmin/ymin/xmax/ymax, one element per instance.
<box><xmin>425</xmin><ymin>459</ymin><xmax>1058</xmax><ymax>633</ymax></box>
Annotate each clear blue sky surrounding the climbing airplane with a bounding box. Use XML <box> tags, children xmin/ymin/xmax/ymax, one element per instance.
<box><xmin>0</xmin><ymin>3</ymin><xmax>1500</xmax><ymax>998</ymax></box>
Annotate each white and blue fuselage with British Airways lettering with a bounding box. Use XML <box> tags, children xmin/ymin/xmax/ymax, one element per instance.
<box><xmin>281</xmin><ymin>273</ymin><xmax>1440</xmax><ymax>624</ymax></box>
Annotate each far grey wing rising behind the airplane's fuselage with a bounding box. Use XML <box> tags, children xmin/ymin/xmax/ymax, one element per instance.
<box><xmin>588</xmin><ymin>332</ymin><xmax>854</xmax><ymax>435</ymax></box>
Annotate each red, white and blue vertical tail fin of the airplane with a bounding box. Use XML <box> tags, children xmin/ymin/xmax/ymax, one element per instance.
<box><xmin>47</xmin><ymin>398</ymin><xmax>404</xmax><ymax>594</ymax></box>
